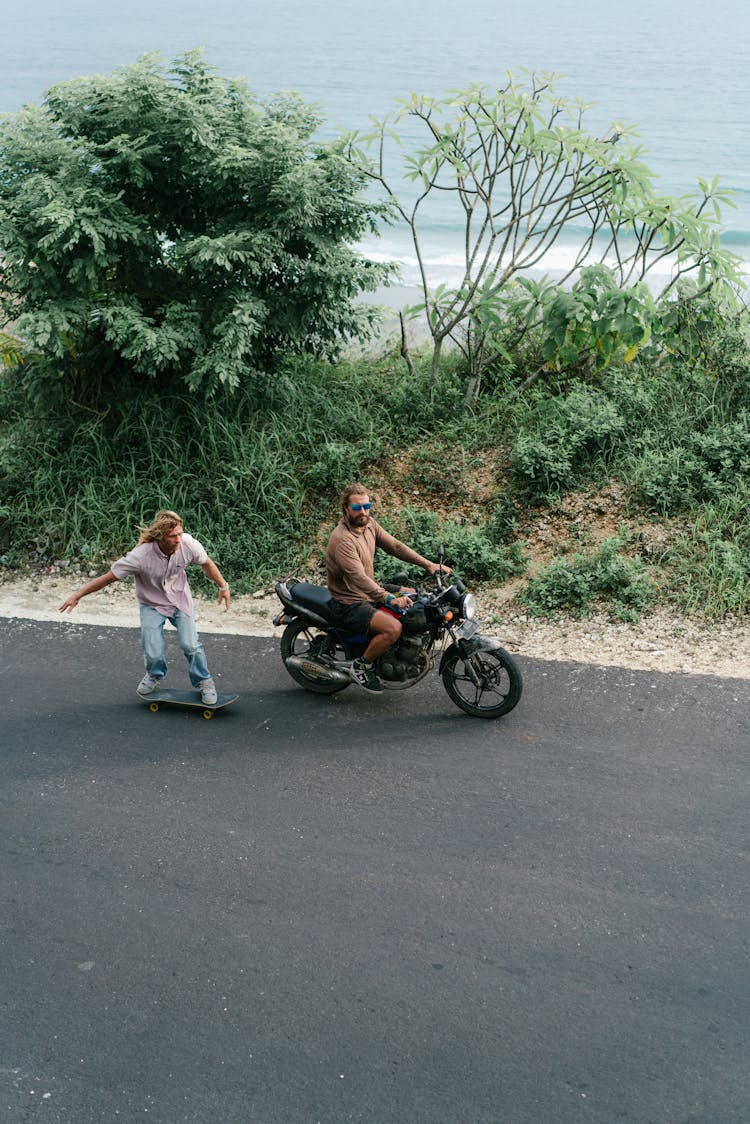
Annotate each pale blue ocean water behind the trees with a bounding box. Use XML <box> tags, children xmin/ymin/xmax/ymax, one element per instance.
<box><xmin>0</xmin><ymin>0</ymin><xmax>750</xmax><ymax>284</ymax></box>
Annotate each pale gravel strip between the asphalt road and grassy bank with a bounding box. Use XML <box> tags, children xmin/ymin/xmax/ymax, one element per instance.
<box><xmin>0</xmin><ymin>573</ymin><xmax>750</xmax><ymax>680</ymax></box>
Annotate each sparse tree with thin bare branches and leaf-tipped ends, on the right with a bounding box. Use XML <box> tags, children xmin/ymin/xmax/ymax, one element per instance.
<box><xmin>342</xmin><ymin>74</ymin><xmax>740</xmax><ymax>386</ymax></box>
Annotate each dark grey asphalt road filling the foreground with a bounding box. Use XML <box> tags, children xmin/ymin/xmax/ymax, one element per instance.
<box><xmin>0</xmin><ymin>620</ymin><xmax>750</xmax><ymax>1124</ymax></box>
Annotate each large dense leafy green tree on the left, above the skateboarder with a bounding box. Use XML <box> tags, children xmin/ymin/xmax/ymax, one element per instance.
<box><xmin>0</xmin><ymin>52</ymin><xmax>388</xmax><ymax>404</ymax></box>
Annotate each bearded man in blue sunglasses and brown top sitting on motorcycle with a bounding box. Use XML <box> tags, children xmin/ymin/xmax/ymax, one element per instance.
<box><xmin>326</xmin><ymin>483</ymin><xmax>451</xmax><ymax>691</ymax></box>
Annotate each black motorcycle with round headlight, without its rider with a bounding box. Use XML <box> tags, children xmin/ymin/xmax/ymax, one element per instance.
<box><xmin>273</xmin><ymin>550</ymin><xmax>523</xmax><ymax>718</ymax></box>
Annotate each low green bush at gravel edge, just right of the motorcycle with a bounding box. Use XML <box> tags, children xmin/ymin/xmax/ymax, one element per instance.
<box><xmin>519</xmin><ymin>537</ymin><xmax>656</xmax><ymax>620</ymax></box>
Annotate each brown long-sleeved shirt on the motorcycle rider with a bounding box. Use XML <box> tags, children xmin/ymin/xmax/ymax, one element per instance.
<box><xmin>326</xmin><ymin>518</ymin><xmax>430</xmax><ymax>605</ymax></box>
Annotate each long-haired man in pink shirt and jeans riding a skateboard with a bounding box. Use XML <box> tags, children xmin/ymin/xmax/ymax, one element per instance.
<box><xmin>60</xmin><ymin>511</ymin><xmax>232</xmax><ymax>706</ymax></box>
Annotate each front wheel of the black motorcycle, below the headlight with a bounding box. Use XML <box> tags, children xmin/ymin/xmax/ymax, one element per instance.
<box><xmin>442</xmin><ymin>647</ymin><xmax>523</xmax><ymax>718</ymax></box>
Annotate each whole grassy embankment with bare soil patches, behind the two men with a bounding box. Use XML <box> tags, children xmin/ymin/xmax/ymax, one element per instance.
<box><xmin>0</xmin><ymin>316</ymin><xmax>750</xmax><ymax>619</ymax></box>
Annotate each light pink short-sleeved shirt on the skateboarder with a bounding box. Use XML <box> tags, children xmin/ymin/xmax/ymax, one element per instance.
<box><xmin>111</xmin><ymin>535</ymin><xmax>208</xmax><ymax>617</ymax></box>
